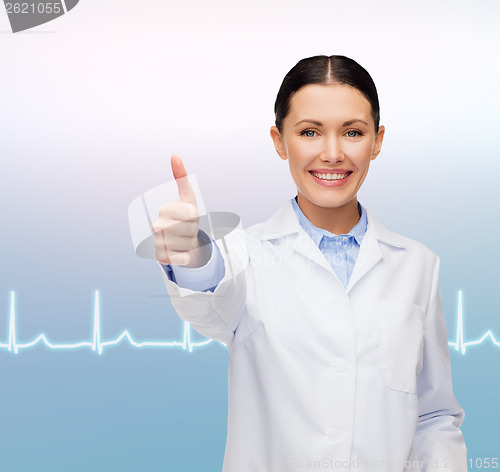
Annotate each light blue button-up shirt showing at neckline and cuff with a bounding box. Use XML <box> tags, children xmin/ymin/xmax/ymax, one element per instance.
<box><xmin>163</xmin><ymin>197</ymin><xmax>367</xmax><ymax>292</ymax></box>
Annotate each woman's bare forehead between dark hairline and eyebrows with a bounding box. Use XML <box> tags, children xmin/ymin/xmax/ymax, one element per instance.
<box><xmin>287</xmin><ymin>84</ymin><xmax>373</xmax><ymax>123</ymax></box>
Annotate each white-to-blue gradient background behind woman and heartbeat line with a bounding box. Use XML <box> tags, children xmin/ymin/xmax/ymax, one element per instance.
<box><xmin>0</xmin><ymin>0</ymin><xmax>500</xmax><ymax>472</ymax></box>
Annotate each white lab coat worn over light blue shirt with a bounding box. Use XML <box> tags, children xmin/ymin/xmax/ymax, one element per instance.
<box><xmin>162</xmin><ymin>200</ymin><xmax>467</xmax><ymax>472</ymax></box>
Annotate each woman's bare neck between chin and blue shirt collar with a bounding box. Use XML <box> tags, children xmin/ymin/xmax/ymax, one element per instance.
<box><xmin>297</xmin><ymin>193</ymin><xmax>360</xmax><ymax>234</ymax></box>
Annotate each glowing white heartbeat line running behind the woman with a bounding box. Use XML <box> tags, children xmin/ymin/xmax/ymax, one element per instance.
<box><xmin>0</xmin><ymin>290</ymin><xmax>500</xmax><ymax>355</ymax></box>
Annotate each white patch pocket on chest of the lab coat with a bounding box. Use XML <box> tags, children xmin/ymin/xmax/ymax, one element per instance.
<box><xmin>378</xmin><ymin>299</ymin><xmax>425</xmax><ymax>395</ymax></box>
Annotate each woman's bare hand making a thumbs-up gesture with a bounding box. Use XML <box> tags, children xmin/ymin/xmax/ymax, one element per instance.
<box><xmin>153</xmin><ymin>154</ymin><xmax>210</xmax><ymax>267</ymax></box>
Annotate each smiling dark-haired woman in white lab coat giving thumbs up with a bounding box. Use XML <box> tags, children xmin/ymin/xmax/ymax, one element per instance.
<box><xmin>153</xmin><ymin>56</ymin><xmax>467</xmax><ymax>472</ymax></box>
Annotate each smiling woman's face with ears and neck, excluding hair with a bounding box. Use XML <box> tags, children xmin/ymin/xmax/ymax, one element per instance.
<box><xmin>271</xmin><ymin>83</ymin><xmax>385</xmax><ymax>234</ymax></box>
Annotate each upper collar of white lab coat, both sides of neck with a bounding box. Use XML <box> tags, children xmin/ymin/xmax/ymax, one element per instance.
<box><xmin>260</xmin><ymin>199</ymin><xmax>408</xmax><ymax>253</ymax></box>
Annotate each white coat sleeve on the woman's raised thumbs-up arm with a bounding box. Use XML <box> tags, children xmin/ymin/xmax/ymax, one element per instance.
<box><xmin>158</xmin><ymin>224</ymin><xmax>249</xmax><ymax>347</ymax></box>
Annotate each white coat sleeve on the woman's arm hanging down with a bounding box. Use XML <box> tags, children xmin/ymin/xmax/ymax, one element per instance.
<box><xmin>414</xmin><ymin>255</ymin><xmax>467</xmax><ymax>472</ymax></box>
